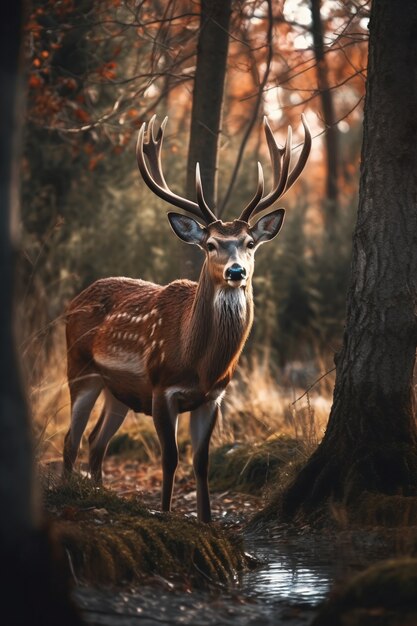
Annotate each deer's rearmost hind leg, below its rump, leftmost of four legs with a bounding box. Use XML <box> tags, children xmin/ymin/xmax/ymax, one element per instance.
<box><xmin>63</xmin><ymin>372</ymin><xmax>103</xmax><ymax>477</ymax></box>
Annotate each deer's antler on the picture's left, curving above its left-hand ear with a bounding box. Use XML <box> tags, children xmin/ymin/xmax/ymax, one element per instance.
<box><xmin>136</xmin><ymin>115</ymin><xmax>217</xmax><ymax>224</ymax></box>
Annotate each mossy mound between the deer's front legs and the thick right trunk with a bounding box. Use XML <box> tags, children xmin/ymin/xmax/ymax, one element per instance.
<box><xmin>209</xmin><ymin>435</ymin><xmax>304</xmax><ymax>493</ymax></box>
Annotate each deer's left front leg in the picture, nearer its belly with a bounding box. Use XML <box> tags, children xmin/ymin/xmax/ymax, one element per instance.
<box><xmin>152</xmin><ymin>391</ymin><xmax>178</xmax><ymax>511</ymax></box>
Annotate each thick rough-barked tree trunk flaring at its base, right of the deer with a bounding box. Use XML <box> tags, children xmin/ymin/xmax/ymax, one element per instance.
<box><xmin>282</xmin><ymin>0</ymin><xmax>417</xmax><ymax>517</ymax></box>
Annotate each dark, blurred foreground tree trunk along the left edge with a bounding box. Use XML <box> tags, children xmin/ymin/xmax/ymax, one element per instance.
<box><xmin>0</xmin><ymin>0</ymin><xmax>81</xmax><ymax>626</ymax></box>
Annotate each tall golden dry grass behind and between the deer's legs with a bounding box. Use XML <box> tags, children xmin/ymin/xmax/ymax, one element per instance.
<box><xmin>30</xmin><ymin>325</ymin><xmax>333</xmax><ymax>488</ymax></box>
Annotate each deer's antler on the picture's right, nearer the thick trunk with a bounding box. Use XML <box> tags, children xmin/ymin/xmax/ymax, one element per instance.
<box><xmin>239</xmin><ymin>115</ymin><xmax>311</xmax><ymax>222</ymax></box>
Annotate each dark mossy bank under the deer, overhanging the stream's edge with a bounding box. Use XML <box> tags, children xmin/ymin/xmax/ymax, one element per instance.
<box><xmin>55</xmin><ymin>515</ymin><xmax>245</xmax><ymax>585</ymax></box>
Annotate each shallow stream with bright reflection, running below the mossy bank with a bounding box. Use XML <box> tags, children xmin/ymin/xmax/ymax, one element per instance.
<box><xmin>75</xmin><ymin>528</ymin><xmax>368</xmax><ymax>626</ymax></box>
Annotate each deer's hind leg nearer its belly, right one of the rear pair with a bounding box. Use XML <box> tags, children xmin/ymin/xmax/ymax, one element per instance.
<box><xmin>88</xmin><ymin>388</ymin><xmax>129</xmax><ymax>484</ymax></box>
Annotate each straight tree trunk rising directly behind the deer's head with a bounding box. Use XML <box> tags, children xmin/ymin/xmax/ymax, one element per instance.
<box><xmin>183</xmin><ymin>0</ymin><xmax>231</xmax><ymax>278</ymax></box>
